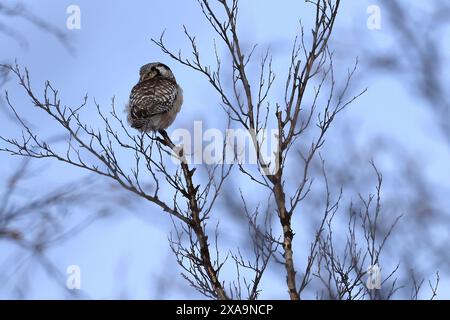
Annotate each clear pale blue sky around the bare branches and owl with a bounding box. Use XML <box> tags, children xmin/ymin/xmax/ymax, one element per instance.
<box><xmin>0</xmin><ymin>0</ymin><xmax>450</xmax><ymax>298</ymax></box>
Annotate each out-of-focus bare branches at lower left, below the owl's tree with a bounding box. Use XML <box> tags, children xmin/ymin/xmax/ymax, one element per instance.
<box><xmin>0</xmin><ymin>159</ymin><xmax>130</xmax><ymax>298</ymax></box>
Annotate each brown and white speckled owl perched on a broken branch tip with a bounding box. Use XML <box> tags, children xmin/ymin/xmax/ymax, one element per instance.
<box><xmin>127</xmin><ymin>62</ymin><xmax>183</xmax><ymax>132</ymax></box>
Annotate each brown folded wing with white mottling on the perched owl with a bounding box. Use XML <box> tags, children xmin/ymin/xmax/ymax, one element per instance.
<box><xmin>130</xmin><ymin>78</ymin><xmax>178</xmax><ymax>119</ymax></box>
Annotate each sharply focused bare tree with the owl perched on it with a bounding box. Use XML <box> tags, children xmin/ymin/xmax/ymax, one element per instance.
<box><xmin>1</xmin><ymin>0</ymin><xmax>437</xmax><ymax>300</ymax></box>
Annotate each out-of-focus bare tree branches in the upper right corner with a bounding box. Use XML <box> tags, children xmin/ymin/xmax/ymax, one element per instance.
<box><xmin>365</xmin><ymin>0</ymin><xmax>450</xmax><ymax>139</ymax></box>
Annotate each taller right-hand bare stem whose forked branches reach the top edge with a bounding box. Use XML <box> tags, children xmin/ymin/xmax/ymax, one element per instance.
<box><xmin>153</xmin><ymin>0</ymin><xmax>363</xmax><ymax>300</ymax></box>
